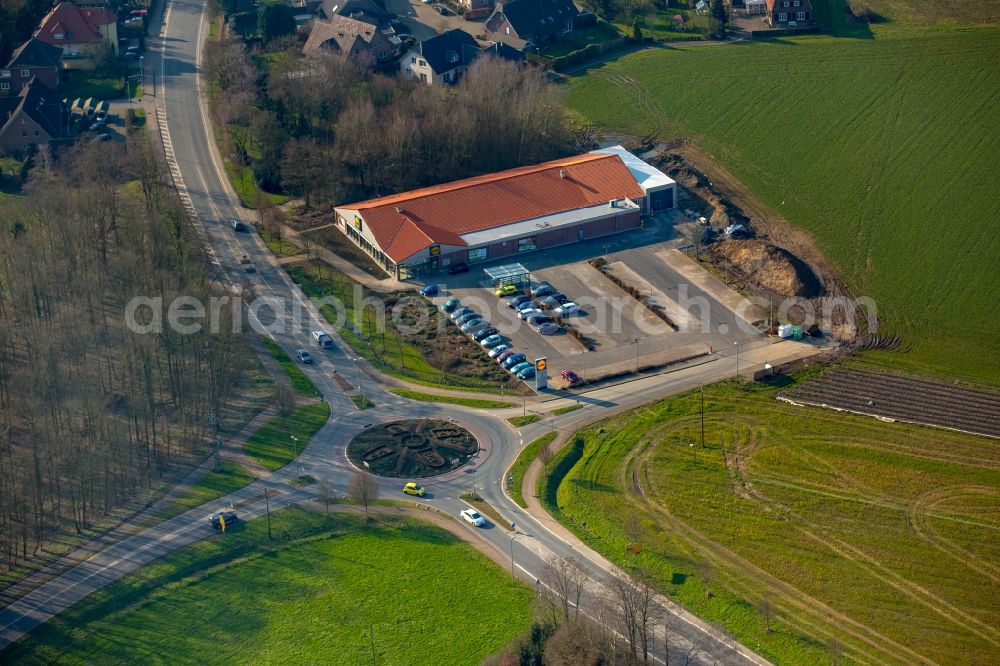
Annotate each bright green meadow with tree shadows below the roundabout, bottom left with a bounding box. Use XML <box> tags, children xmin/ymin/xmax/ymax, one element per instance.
<box><xmin>5</xmin><ymin>509</ymin><xmax>532</xmax><ymax>666</ymax></box>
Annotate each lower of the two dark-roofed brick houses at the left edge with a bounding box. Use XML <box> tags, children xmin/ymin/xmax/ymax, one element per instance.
<box><xmin>0</xmin><ymin>79</ymin><xmax>70</xmax><ymax>154</ymax></box>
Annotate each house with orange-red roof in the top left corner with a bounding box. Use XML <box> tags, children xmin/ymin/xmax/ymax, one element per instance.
<box><xmin>34</xmin><ymin>2</ymin><xmax>118</xmax><ymax>66</ymax></box>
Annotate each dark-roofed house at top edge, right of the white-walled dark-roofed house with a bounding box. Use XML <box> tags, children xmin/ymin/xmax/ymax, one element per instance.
<box><xmin>486</xmin><ymin>0</ymin><xmax>580</xmax><ymax>51</ymax></box>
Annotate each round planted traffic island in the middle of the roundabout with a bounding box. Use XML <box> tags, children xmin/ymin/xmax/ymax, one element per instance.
<box><xmin>347</xmin><ymin>419</ymin><xmax>479</xmax><ymax>479</ymax></box>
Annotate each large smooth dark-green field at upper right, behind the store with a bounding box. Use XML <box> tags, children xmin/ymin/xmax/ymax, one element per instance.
<box><xmin>568</xmin><ymin>26</ymin><xmax>1000</xmax><ymax>385</ymax></box>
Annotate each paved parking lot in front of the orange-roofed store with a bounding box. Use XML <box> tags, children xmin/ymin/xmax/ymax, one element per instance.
<box><xmin>418</xmin><ymin>213</ymin><xmax>766</xmax><ymax>387</ymax></box>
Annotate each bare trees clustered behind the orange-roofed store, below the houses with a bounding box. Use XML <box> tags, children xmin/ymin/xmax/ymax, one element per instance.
<box><xmin>206</xmin><ymin>39</ymin><xmax>589</xmax><ymax>205</ymax></box>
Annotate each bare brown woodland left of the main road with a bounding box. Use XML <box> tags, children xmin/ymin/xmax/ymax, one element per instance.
<box><xmin>0</xmin><ymin>138</ymin><xmax>247</xmax><ymax>570</ymax></box>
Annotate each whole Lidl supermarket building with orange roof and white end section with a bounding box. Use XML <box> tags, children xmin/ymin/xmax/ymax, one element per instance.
<box><xmin>335</xmin><ymin>146</ymin><xmax>676</xmax><ymax>279</ymax></box>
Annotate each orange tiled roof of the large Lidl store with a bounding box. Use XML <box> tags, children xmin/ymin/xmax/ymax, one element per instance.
<box><xmin>342</xmin><ymin>153</ymin><xmax>644</xmax><ymax>262</ymax></box>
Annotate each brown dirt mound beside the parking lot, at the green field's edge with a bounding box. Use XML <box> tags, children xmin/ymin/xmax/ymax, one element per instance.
<box><xmin>711</xmin><ymin>240</ymin><xmax>823</xmax><ymax>298</ymax></box>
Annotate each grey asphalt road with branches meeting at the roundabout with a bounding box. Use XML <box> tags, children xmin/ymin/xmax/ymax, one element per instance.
<box><xmin>0</xmin><ymin>0</ymin><xmax>788</xmax><ymax>664</ymax></box>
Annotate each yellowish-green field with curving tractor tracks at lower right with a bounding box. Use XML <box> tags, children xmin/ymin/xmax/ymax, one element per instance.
<box><xmin>537</xmin><ymin>382</ymin><xmax>1000</xmax><ymax>664</ymax></box>
